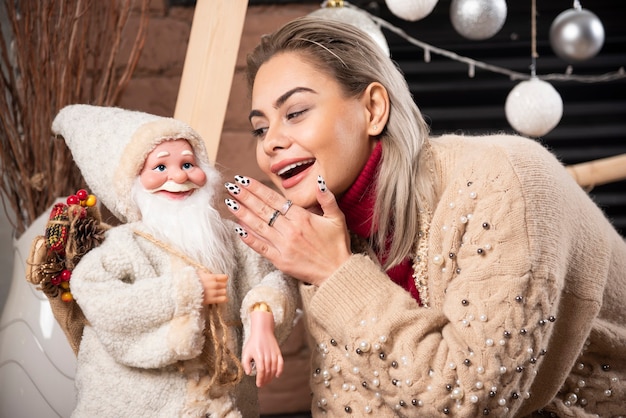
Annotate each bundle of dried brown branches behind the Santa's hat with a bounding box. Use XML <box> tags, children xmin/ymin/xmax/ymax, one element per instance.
<box><xmin>0</xmin><ymin>0</ymin><xmax>150</xmax><ymax>236</ymax></box>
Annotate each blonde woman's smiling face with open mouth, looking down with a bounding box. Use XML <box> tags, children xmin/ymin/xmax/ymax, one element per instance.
<box><xmin>250</xmin><ymin>52</ymin><xmax>375</xmax><ymax>209</ymax></box>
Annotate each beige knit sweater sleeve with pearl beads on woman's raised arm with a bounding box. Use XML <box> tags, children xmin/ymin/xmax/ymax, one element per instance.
<box><xmin>302</xmin><ymin>137</ymin><xmax>578</xmax><ymax>417</ymax></box>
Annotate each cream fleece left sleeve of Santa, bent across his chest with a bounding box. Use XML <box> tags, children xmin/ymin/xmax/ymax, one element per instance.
<box><xmin>71</xmin><ymin>226</ymin><xmax>204</xmax><ymax>368</ymax></box>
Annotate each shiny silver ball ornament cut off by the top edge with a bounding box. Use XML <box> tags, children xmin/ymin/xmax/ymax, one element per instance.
<box><xmin>450</xmin><ymin>0</ymin><xmax>507</xmax><ymax>41</ymax></box>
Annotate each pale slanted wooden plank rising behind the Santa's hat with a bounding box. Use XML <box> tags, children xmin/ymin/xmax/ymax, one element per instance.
<box><xmin>174</xmin><ymin>0</ymin><xmax>248</xmax><ymax>162</ymax></box>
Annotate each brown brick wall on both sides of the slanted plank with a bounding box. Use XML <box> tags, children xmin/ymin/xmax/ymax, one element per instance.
<box><xmin>119</xmin><ymin>0</ymin><xmax>319</xmax><ymax>188</ymax></box>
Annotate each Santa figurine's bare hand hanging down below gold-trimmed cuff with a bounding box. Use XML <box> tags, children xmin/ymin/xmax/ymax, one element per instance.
<box><xmin>241</xmin><ymin>311</ymin><xmax>283</xmax><ymax>387</ymax></box>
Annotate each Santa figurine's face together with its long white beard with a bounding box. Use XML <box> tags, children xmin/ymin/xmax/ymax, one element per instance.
<box><xmin>131</xmin><ymin>139</ymin><xmax>234</xmax><ymax>274</ymax></box>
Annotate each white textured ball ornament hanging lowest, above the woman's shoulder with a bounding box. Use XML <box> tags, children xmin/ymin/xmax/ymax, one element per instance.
<box><xmin>504</xmin><ymin>77</ymin><xmax>563</xmax><ymax>137</ymax></box>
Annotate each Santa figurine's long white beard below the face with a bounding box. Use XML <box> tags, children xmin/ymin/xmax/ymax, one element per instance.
<box><xmin>133</xmin><ymin>180</ymin><xmax>234</xmax><ymax>275</ymax></box>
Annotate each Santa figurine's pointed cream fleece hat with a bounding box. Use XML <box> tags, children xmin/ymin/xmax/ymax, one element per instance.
<box><xmin>52</xmin><ymin>104</ymin><xmax>209</xmax><ymax>222</ymax></box>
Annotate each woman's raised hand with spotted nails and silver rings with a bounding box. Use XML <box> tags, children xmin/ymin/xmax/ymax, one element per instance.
<box><xmin>226</xmin><ymin>176</ymin><xmax>351</xmax><ymax>286</ymax></box>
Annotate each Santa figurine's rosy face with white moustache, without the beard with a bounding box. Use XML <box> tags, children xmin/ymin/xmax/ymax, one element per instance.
<box><xmin>139</xmin><ymin>139</ymin><xmax>206</xmax><ymax>200</ymax></box>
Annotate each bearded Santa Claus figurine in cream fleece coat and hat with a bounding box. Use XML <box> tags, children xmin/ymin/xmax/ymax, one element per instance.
<box><xmin>52</xmin><ymin>105</ymin><xmax>298</xmax><ymax>418</ymax></box>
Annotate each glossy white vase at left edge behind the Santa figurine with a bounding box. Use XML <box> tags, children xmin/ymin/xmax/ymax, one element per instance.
<box><xmin>0</xmin><ymin>201</ymin><xmax>76</xmax><ymax>418</ymax></box>
